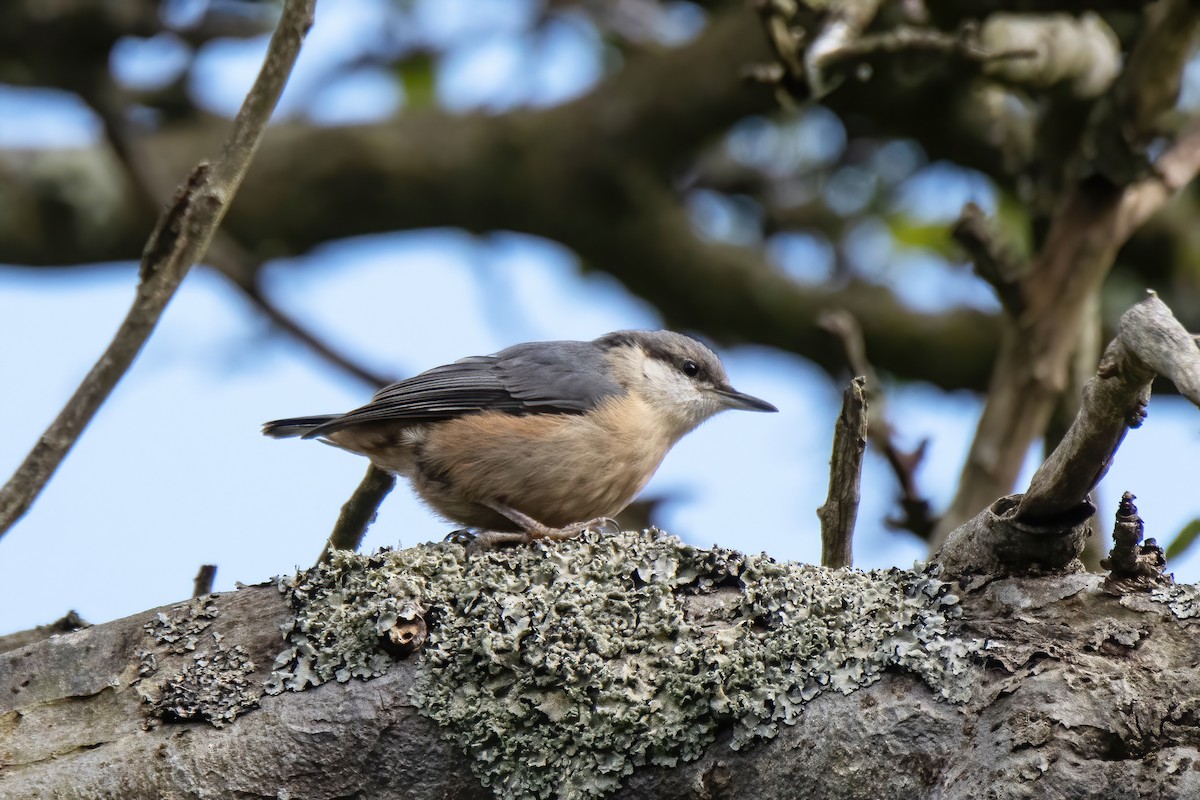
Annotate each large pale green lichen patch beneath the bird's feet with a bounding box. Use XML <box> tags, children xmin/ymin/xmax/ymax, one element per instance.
<box><xmin>272</xmin><ymin>531</ymin><xmax>984</xmax><ymax>800</ymax></box>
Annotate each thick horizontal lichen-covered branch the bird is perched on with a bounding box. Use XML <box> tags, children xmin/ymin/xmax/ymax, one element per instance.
<box><xmin>7</xmin><ymin>533</ymin><xmax>1200</xmax><ymax>800</ymax></box>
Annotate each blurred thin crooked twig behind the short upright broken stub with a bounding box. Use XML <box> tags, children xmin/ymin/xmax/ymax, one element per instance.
<box><xmin>817</xmin><ymin>308</ymin><xmax>937</xmax><ymax>541</ymax></box>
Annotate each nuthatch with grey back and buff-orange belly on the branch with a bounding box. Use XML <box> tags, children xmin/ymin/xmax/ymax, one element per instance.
<box><xmin>263</xmin><ymin>331</ymin><xmax>776</xmax><ymax>542</ymax></box>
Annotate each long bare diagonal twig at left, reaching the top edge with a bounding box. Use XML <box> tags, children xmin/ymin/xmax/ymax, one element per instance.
<box><xmin>0</xmin><ymin>0</ymin><xmax>316</xmax><ymax>536</ymax></box>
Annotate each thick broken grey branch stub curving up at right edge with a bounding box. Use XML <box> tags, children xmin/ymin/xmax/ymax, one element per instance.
<box><xmin>936</xmin><ymin>293</ymin><xmax>1200</xmax><ymax>577</ymax></box>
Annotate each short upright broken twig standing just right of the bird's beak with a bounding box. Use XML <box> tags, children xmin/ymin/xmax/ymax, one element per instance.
<box><xmin>817</xmin><ymin>378</ymin><xmax>866</xmax><ymax>567</ymax></box>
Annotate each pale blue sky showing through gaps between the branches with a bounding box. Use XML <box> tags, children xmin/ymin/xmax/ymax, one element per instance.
<box><xmin>0</xmin><ymin>0</ymin><xmax>1200</xmax><ymax>633</ymax></box>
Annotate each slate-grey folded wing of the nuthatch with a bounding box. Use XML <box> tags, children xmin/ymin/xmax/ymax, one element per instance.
<box><xmin>306</xmin><ymin>342</ymin><xmax>622</xmax><ymax>438</ymax></box>
